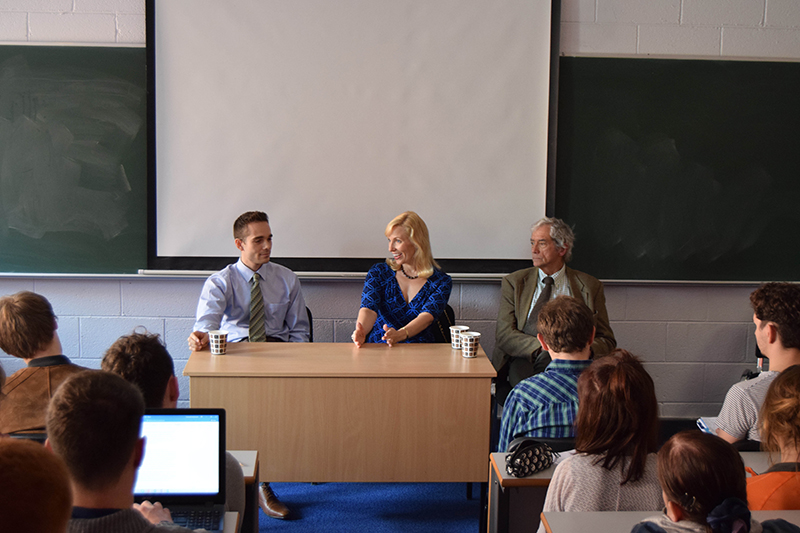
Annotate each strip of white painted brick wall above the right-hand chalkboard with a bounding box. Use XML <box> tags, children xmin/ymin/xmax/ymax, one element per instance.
<box><xmin>561</xmin><ymin>0</ymin><xmax>800</xmax><ymax>59</ymax></box>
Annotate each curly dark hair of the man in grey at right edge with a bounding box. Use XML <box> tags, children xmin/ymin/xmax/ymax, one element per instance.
<box><xmin>750</xmin><ymin>283</ymin><xmax>800</xmax><ymax>349</ymax></box>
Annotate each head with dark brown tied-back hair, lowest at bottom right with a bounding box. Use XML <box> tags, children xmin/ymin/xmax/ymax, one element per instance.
<box><xmin>658</xmin><ymin>430</ymin><xmax>749</xmax><ymax>531</ymax></box>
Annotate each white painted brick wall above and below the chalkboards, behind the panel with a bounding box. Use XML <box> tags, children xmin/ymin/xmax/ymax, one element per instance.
<box><xmin>0</xmin><ymin>0</ymin><xmax>800</xmax><ymax>416</ymax></box>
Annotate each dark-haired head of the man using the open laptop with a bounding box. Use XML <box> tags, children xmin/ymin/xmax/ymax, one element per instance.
<box><xmin>47</xmin><ymin>370</ymin><xmax>144</xmax><ymax>491</ymax></box>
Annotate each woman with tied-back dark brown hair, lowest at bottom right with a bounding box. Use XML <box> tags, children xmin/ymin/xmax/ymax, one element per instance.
<box><xmin>631</xmin><ymin>430</ymin><xmax>800</xmax><ymax>533</ymax></box>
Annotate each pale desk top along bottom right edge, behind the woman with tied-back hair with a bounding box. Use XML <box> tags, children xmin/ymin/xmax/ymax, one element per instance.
<box><xmin>542</xmin><ymin>511</ymin><xmax>800</xmax><ymax>533</ymax></box>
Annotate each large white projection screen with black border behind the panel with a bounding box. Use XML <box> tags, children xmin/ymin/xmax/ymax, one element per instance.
<box><xmin>153</xmin><ymin>0</ymin><xmax>553</xmax><ymax>272</ymax></box>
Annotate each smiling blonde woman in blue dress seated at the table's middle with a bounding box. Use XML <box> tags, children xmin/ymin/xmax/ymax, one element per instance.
<box><xmin>351</xmin><ymin>211</ymin><xmax>453</xmax><ymax>348</ymax></box>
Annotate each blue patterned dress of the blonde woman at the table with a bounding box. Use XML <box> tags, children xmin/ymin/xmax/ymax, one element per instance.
<box><xmin>361</xmin><ymin>263</ymin><xmax>453</xmax><ymax>342</ymax></box>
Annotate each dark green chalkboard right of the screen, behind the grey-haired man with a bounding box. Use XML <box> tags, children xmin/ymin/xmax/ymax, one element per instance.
<box><xmin>555</xmin><ymin>57</ymin><xmax>800</xmax><ymax>281</ymax></box>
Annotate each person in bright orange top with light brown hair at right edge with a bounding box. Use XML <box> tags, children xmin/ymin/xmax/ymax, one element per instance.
<box><xmin>747</xmin><ymin>365</ymin><xmax>800</xmax><ymax>511</ymax></box>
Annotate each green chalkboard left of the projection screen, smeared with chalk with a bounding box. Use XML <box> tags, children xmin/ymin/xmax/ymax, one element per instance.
<box><xmin>0</xmin><ymin>46</ymin><xmax>147</xmax><ymax>273</ymax></box>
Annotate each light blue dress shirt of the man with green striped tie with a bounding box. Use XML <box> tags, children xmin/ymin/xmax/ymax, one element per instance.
<box><xmin>194</xmin><ymin>259</ymin><xmax>309</xmax><ymax>342</ymax></box>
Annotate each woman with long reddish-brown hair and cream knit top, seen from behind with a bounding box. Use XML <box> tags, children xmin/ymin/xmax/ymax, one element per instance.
<box><xmin>544</xmin><ymin>349</ymin><xmax>662</xmax><ymax>511</ymax></box>
